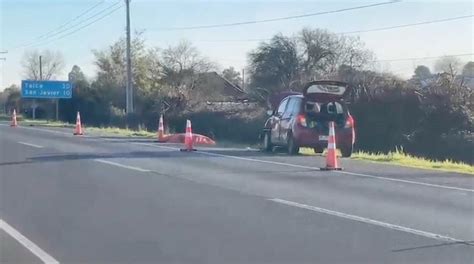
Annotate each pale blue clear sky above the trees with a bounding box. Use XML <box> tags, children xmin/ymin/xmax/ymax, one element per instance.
<box><xmin>0</xmin><ymin>0</ymin><xmax>474</xmax><ymax>90</ymax></box>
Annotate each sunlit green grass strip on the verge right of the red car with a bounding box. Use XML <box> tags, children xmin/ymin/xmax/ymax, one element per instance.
<box><xmin>300</xmin><ymin>148</ymin><xmax>474</xmax><ymax>175</ymax></box>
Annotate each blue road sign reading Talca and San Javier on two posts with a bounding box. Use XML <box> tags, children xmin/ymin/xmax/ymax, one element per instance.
<box><xmin>21</xmin><ymin>80</ymin><xmax>72</xmax><ymax>120</ymax></box>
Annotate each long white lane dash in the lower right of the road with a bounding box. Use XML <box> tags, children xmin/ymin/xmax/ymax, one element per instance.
<box><xmin>268</xmin><ymin>198</ymin><xmax>465</xmax><ymax>243</ymax></box>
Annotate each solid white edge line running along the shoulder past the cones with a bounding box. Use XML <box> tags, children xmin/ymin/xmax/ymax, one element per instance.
<box><xmin>135</xmin><ymin>143</ymin><xmax>474</xmax><ymax>193</ymax></box>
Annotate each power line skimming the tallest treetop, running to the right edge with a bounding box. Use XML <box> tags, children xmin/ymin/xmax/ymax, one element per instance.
<box><xmin>191</xmin><ymin>15</ymin><xmax>474</xmax><ymax>42</ymax></box>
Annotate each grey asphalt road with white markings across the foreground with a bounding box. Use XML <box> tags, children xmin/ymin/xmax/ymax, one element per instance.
<box><xmin>0</xmin><ymin>123</ymin><xmax>474</xmax><ymax>264</ymax></box>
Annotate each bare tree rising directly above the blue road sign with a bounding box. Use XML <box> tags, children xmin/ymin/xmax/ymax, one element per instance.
<box><xmin>21</xmin><ymin>50</ymin><xmax>64</xmax><ymax>80</ymax></box>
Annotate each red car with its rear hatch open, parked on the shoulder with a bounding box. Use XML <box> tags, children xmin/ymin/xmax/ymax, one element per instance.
<box><xmin>262</xmin><ymin>81</ymin><xmax>355</xmax><ymax>157</ymax></box>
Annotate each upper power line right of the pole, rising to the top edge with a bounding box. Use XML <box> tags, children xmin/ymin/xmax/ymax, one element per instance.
<box><xmin>152</xmin><ymin>0</ymin><xmax>400</xmax><ymax>31</ymax></box>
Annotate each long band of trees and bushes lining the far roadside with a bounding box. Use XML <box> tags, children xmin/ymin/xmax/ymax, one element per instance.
<box><xmin>0</xmin><ymin>28</ymin><xmax>474</xmax><ymax>165</ymax></box>
